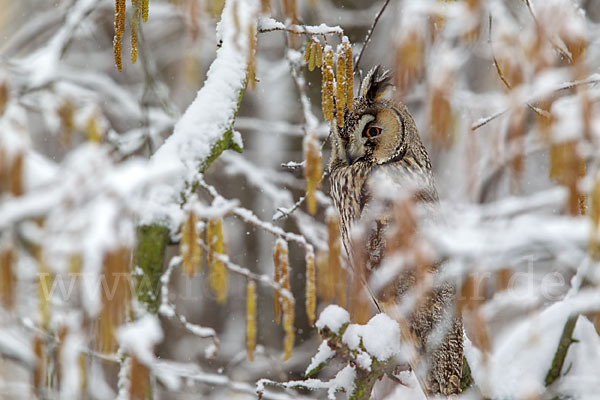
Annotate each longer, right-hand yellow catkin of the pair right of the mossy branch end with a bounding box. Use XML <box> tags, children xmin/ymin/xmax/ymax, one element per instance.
<box><xmin>206</xmin><ymin>218</ymin><xmax>228</xmax><ymax>304</ymax></box>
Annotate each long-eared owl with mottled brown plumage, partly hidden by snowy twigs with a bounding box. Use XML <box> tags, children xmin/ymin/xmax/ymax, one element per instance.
<box><xmin>329</xmin><ymin>67</ymin><xmax>463</xmax><ymax>395</ymax></box>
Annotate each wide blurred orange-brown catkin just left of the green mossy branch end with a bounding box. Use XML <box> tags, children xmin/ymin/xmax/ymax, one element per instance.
<box><xmin>97</xmin><ymin>247</ymin><xmax>132</xmax><ymax>353</ymax></box>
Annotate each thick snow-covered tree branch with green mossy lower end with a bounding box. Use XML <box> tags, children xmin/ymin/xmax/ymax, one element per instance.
<box><xmin>135</xmin><ymin>0</ymin><xmax>258</xmax><ymax>313</ymax></box>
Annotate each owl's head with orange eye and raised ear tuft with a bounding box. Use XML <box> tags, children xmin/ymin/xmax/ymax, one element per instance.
<box><xmin>332</xmin><ymin>66</ymin><xmax>422</xmax><ymax>166</ymax></box>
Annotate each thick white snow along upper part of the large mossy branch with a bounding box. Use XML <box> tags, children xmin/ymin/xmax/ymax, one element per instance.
<box><xmin>142</xmin><ymin>0</ymin><xmax>258</xmax><ymax>231</ymax></box>
